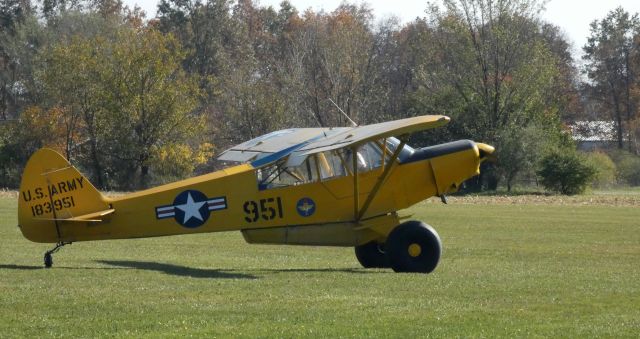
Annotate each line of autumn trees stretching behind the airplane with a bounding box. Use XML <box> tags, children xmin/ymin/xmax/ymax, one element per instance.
<box><xmin>0</xmin><ymin>0</ymin><xmax>640</xmax><ymax>190</ymax></box>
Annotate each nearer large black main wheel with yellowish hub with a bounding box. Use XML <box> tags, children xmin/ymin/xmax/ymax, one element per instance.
<box><xmin>386</xmin><ymin>221</ymin><xmax>442</xmax><ymax>273</ymax></box>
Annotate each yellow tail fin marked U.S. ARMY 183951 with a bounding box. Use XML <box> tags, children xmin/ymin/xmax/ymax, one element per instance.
<box><xmin>18</xmin><ymin>148</ymin><xmax>114</xmax><ymax>242</ymax></box>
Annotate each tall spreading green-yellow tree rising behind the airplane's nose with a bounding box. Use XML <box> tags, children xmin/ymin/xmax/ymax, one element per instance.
<box><xmin>404</xmin><ymin>0</ymin><xmax>562</xmax><ymax>187</ymax></box>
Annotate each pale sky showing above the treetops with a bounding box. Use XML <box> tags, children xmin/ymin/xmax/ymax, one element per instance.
<box><xmin>124</xmin><ymin>0</ymin><xmax>640</xmax><ymax>55</ymax></box>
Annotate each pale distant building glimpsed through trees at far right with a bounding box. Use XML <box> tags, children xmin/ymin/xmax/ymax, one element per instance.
<box><xmin>569</xmin><ymin>120</ymin><xmax>617</xmax><ymax>151</ymax></box>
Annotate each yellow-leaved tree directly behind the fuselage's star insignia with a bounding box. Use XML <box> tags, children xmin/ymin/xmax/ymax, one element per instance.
<box><xmin>100</xmin><ymin>29</ymin><xmax>203</xmax><ymax>188</ymax></box>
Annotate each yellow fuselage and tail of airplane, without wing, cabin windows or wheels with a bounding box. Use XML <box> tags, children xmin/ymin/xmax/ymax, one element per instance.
<box><xmin>18</xmin><ymin>121</ymin><xmax>490</xmax><ymax>246</ymax></box>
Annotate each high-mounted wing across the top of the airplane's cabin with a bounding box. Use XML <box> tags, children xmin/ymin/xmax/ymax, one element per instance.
<box><xmin>218</xmin><ymin>115</ymin><xmax>450</xmax><ymax>167</ymax></box>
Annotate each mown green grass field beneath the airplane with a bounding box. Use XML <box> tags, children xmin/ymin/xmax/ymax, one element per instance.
<box><xmin>0</xmin><ymin>192</ymin><xmax>640</xmax><ymax>338</ymax></box>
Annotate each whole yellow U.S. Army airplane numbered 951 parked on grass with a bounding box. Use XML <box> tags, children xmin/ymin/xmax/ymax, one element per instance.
<box><xmin>18</xmin><ymin>116</ymin><xmax>494</xmax><ymax>273</ymax></box>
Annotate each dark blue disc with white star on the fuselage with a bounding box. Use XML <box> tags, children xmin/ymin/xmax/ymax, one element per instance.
<box><xmin>173</xmin><ymin>190</ymin><xmax>211</xmax><ymax>228</ymax></box>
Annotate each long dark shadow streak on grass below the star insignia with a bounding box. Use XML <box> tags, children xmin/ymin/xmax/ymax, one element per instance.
<box><xmin>96</xmin><ymin>260</ymin><xmax>257</xmax><ymax>279</ymax></box>
